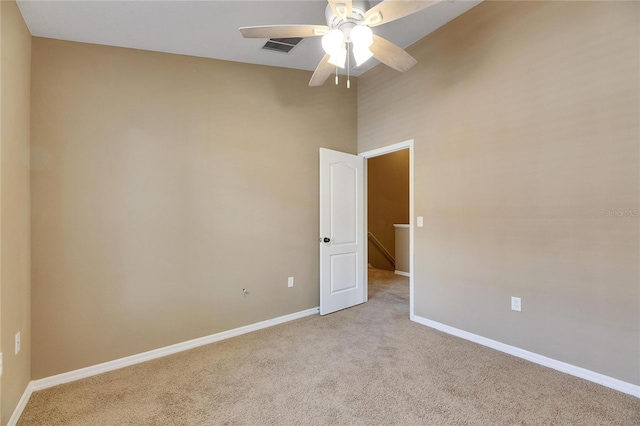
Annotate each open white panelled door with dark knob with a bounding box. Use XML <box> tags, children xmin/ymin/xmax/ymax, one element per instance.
<box><xmin>320</xmin><ymin>148</ymin><xmax>367</xmax><ymax>315</ymax></box>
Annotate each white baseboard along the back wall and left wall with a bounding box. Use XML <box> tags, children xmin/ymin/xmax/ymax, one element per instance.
<box><xmin>9</xmin><ymin>308</ymin><xmax>319</xmax><ymax>426</ymax></box>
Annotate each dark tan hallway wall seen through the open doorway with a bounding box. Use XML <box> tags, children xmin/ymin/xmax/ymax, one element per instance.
<box><xmin>367</xmin><ymin>149</ymin><xmax>409</xmax><ymax>270</ymax></box>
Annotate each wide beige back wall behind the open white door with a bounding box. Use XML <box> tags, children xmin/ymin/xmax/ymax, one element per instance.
<box><xmin>31</xmin><ymin>38</ymin><xmax>357</xmax><ymax>379</ymax></box>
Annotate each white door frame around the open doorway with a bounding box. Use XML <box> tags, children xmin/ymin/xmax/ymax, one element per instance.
<box><xmin>358</xmin><ymin>139</ymin><xmax>415</xmax><ymax>321</ymax></box>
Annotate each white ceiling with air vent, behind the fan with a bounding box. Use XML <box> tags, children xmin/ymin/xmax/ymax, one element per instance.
<box><xmin>18</xmin><ymin>0</ymin><xmax>481</xmax><ymax>76</ymax></box>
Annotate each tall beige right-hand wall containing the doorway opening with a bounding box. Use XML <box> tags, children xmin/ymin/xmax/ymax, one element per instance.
<box><xmin>358</xmin><ymin>2</ymin><xmax>640</xmax><ymax>385</ymax></box>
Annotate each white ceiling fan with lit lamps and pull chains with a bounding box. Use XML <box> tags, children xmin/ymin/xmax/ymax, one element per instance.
<box><xmin>240</xmin><ymin>0</ymin><xmax>438</xmax><ymax>87</ymax></box>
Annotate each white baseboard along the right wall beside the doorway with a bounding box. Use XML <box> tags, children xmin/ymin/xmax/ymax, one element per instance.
<box><xmin>412</xmin><ymin>315</ymin><xmax>640</xmax><ymax>398</ymax></box>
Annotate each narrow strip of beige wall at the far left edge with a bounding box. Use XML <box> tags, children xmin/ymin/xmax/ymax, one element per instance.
<box><xmin>0</xmin><ymin>1</ymin><xmax>31</xmax><ymax>425</ymax></box>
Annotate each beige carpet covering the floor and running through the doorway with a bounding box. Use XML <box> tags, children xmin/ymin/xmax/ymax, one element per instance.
<box><xmin>19</xmin><ymin>270</ymin><xmax>640</xmax><ymax>426</ymax></box>
